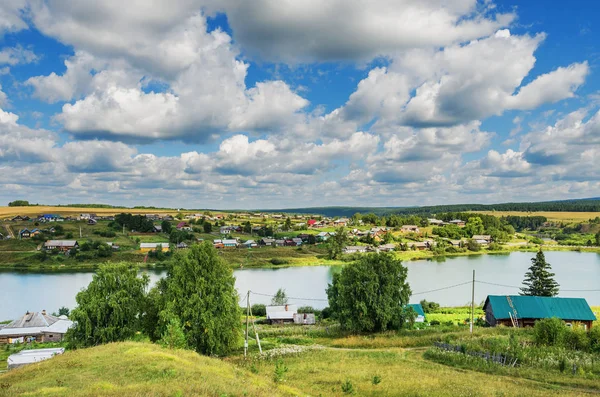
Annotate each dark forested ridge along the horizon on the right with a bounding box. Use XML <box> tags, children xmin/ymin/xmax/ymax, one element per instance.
<box><xmin>261</xmin><ymin>197</ymin><xmax>600</xmax><ymax>217</ymax></box>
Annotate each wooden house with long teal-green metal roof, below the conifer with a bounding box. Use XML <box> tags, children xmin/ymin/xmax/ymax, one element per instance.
<box><xmin>483</xmin><ymin>295</ymin><xmax>596</xmax><ymax>329</ymax></box>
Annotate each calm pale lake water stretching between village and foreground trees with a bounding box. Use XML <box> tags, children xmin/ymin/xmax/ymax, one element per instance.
<box><xmin>0</xmin><ymin>252</ymin><xmax>600</xmax><ymax>320</ymax></box>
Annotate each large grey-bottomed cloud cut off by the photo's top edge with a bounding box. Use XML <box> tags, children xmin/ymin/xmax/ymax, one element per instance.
<box><xmin>209</xmin><ymin>0</ymin><xmax>514</xmax><ymax>63</ymax></box>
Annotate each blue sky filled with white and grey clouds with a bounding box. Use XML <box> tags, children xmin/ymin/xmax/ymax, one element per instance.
<box><xmin>0</xmin><ymin>0</ymin><xmax>600</xmax><ymax>209</ymax></box>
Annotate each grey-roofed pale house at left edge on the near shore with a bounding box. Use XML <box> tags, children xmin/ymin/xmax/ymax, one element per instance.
<box><xmin>0</xmin><ymin>310</ymin><xmax>73</xmax><ymax>344</ymax></box>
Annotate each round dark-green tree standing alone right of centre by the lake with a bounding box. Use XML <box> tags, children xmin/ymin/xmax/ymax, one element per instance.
<box><xmin>327</xmin><ymin>253</ymin><xmax>411</xmax><ymax>332</ymax></box>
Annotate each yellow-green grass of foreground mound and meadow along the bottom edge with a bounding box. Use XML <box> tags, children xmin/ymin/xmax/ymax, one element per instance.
<box><xmin>0</xmin><ymin>340</ymin><xmax>590</xmax><ymax>397</ymax></box>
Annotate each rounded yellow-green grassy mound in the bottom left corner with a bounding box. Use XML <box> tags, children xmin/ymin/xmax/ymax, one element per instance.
<box><xmin>0</xmin><ymin>342</ymin><xmax>299</xmax><ymax>397</ymax></box>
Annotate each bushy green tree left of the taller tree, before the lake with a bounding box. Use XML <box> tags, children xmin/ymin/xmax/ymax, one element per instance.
<box><xmin>67</xmin><ymin>263</ymin><xmax>150</xmax><ymax>347</ymax></box>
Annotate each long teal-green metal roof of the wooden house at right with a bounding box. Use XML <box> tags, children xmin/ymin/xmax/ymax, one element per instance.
<box><xmin>483</xmin><ymin>295</ymin><xmax>596</xmax><ymax>321</ymax></box>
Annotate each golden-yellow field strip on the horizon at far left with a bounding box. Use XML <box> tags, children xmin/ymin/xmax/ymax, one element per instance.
<box><xmin>0</xmin><ymin>206</ymin><xmax>177</xmax><ymax>219</ymax></box>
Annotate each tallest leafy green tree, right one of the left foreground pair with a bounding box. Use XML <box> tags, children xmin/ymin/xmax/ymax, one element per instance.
<box><xmin>157</xmin><ymin>241</ymin><xmax>241</xmax><ymax>355</ymax></box>
